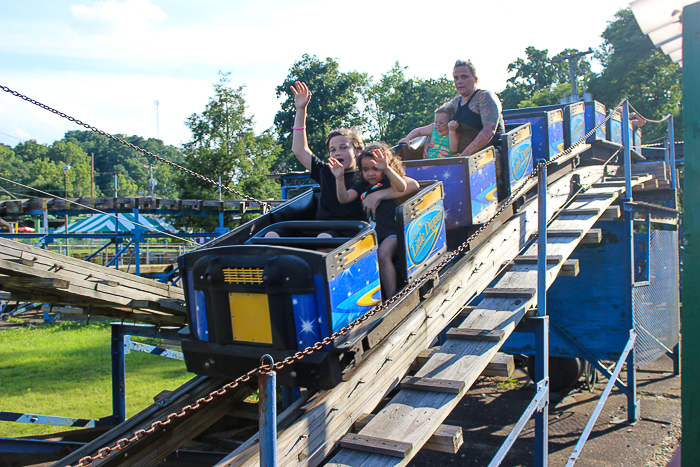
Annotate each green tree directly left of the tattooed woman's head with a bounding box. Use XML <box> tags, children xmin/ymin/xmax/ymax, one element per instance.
<box><xmin>364</xmin><ymin>62</ymin><xmax>456</xmax><ymax>145</ymax></box>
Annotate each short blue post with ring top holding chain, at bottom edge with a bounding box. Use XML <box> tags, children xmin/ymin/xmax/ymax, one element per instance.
<box><xmin>258</xmin><ymin>355</ymin><xmax>277</xmax><ymax>467</ymax></box>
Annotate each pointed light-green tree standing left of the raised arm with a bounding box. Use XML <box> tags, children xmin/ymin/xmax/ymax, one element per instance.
<box><xmin>174</xmin><ymin>73</ymin><xmax>280</xmax><ymax>232</ymax></box>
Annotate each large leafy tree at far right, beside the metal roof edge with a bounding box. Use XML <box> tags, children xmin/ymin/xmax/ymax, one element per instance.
<box><xmin>589</xmin><ymin>8</ymin><xmax>683</xmax><ymax>141</ymax></box>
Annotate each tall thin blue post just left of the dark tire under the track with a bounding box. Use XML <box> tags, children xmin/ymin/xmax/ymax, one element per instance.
<box><xmin>535</xmin><ymin>164</ymin><xmax>549</xmax><ymax>466</ymax></box>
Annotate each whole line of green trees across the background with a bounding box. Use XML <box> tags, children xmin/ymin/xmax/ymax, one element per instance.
<box><xmin>0</xmin><ymin>8</ymin><xmax>682</xmax><ymax>230</ymax></box>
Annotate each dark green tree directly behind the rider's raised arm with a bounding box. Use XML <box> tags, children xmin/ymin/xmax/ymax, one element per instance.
<box><xmin>275</xmin><ymin>54</ymin><xmax>368</xmax><ymax>171</ymax></box>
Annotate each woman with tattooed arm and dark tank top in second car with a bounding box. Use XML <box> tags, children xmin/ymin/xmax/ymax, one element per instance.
<box><xmin>447</xmin><ymin>60</ymin><xmax>505</xmax><ymax>156</ymax></box>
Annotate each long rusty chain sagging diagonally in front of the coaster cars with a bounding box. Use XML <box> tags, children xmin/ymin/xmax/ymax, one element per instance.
<box><xmin>66</xmin><ymin>100</ymin><xmax>624</xmax><ymax>467</ymax></box>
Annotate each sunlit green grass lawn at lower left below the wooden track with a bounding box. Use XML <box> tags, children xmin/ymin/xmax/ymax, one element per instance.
<box><xmin>0</xmin><ymin>322</ymin><xmax>194</xmax><ymax>437</ymax></box>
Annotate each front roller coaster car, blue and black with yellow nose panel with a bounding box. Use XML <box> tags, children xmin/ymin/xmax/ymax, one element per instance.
<box><xmin>179</xmin><ymin>182</ymin><xmax>446</xmax><ymax>388</ymax></box>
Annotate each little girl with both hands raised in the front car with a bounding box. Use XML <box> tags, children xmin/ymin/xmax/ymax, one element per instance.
<box><xmin>328</xmin><ymin>143</ymin><xmax>418</xmax><ymax>299</ymax></box>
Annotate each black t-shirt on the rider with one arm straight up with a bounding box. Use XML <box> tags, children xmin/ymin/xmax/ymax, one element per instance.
<box><xmin>311</xmin><ymin>154</ymin><xmax>364</xmax><ymax>221</ymax></box>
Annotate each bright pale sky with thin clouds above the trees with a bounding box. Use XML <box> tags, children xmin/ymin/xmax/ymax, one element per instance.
<box><xmin>0</xmin><ymin>0</ymin><xmax>629</xmax><ymax>147</ymax></box>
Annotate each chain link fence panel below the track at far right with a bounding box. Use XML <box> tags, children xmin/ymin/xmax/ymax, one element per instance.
<box><xmin>633</xmin><ymin>229</ymin><xmax>680</xmax><ymax>367</ymax></box>
